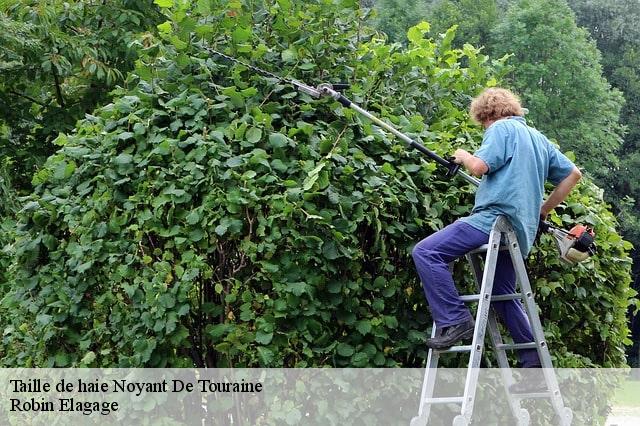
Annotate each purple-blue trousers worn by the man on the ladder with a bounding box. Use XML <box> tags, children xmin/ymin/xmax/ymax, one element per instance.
<box><xmin>412</xmin><ymin>221</ymin><xmax>540</xmax><ymax>368</ymax></box>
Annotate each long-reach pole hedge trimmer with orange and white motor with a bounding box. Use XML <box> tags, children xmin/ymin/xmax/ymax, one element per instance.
<box><xmin>205</xmin><ymin>47</ymin><xmax>596</xmax><ymax>264</ymax></box>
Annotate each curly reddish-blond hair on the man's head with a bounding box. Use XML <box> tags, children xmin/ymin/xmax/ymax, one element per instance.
<box><xmin>469</xmin><ymin>87</ymin><xmax>524</xmax><ymax>124</ymax></box>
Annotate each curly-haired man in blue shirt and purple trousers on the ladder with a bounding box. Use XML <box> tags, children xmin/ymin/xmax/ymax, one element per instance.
<box><xmin>413</xmin><ymin>88</ymin><xmax>582</xmax><ymax>386</ymax></box>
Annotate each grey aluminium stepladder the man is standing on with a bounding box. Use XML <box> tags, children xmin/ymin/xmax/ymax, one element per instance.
<box><xmin>411</xmin><ymin>216</ymin><xmax>573</xmax><ymax>426</ymax></box>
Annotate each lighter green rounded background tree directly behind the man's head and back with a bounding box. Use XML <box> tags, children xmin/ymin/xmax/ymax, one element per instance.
<box><xmin>492</xmin><ymin>0</ymin><xmax>623</xmax><ymax>182</ymax></box>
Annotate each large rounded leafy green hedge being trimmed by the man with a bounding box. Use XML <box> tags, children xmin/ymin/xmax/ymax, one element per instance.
<box><xmin>0</xmin><ymin>0</ymin><xmax>633</xmax><ymax>367</ymax></box>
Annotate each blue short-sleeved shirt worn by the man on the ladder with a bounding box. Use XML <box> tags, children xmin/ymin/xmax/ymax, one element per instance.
<box><xmin>460</xmin><ymin>117</ymin><xmax>575</xmax><ymax>257</ymax></box>
